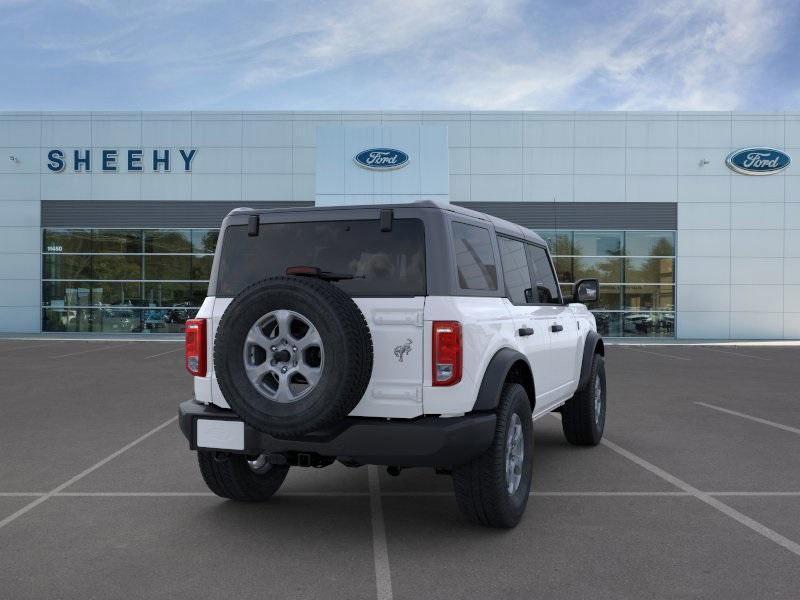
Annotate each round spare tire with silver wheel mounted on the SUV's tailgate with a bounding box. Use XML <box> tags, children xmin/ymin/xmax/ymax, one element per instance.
<box><xmin>214</xmin><ymin>277</ymin><xmax>372</xmax><ymax>437</ymax></box>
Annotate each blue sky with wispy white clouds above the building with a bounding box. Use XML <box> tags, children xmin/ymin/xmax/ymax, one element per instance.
<box><xmin>0</xmin><ymin>0</ymin><xmax>800</xmax><ymax>111</ymax></box>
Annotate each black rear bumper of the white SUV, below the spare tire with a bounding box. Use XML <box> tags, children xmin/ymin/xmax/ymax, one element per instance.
<box><xmin>178</xmin><ymin>400</ymin><xmax>496</xmax><ymax>467</ymax></box>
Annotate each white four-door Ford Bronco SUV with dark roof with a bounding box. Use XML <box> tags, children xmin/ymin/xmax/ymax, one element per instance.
<box><xmin>180</xmin><ymin>201</ymin><xmax>606</xmax><ymax>527</ymax></box>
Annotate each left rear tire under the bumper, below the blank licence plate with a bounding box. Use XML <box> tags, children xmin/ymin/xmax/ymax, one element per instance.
<box><xmin>197</xmin><ymin>450</ymin><xmax>289</xmax><ymax>502</ymax></box>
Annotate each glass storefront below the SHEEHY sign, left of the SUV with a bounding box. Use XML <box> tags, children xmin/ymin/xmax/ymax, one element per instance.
<box><xmin>42</xmin><ymin>229</ymin><xmax>219</xmax><ymax>333</ymax></box>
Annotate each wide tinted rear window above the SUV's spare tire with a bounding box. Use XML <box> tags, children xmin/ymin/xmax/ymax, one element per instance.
<box><xmin>216</xmin><ymin>219</ymin><xmax>425</xmax><ymax>297</ymax></box>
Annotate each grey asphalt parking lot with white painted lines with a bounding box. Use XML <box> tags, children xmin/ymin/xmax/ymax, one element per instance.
<box><xmin>0</xmin><ymin>339</ymin><xmax>800</xmax><ymax>600</ymax></box>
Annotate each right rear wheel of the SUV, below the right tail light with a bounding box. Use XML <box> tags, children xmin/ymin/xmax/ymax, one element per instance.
<box><xmin>453</xmin><ymin>383</ymin><xmax>533</xmax><ymax>528</ymax></box>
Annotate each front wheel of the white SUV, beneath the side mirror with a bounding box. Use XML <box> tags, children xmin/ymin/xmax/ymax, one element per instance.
<box><xmin>561</xmin><ymin>354</ymin><xmax>606</xmax><ymax>446</ymax></box>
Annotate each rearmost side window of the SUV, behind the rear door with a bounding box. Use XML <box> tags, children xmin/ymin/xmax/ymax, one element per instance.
<box><xmin>453</xmin><ymin>223</ymin><xmax>497</xmax><ymax>290</ymax></box>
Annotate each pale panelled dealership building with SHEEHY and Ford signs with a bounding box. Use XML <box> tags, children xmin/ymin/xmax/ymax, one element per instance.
<box><xmin>0</xmin><ymin>112</ymin><xmax>800</xmax><ymax>339</ymax></box>
